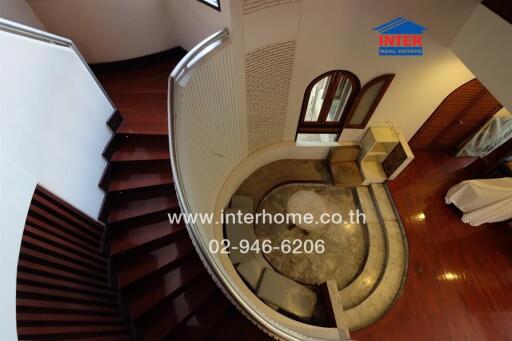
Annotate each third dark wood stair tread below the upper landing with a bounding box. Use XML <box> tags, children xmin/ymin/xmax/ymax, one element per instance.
<box><xmin>108</xmin><ymin>188</ymin><xmax>179</xmax><ymax>223</ymax></box>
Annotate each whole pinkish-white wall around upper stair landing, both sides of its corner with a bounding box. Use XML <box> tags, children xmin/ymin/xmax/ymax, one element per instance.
<box><xmin>26</xmin><ymin>0</ymin><xmax>230</xmax><ymax>63</ymax></box>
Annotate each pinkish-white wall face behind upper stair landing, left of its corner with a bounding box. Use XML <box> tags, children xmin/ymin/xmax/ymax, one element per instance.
<box><xmin>29</xmin><ymin>0</ymin><xmax>177</xmax><ymax>63</ymax></box>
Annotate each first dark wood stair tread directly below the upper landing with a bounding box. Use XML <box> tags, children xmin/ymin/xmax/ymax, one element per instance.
<box><xmin>110</xmin><ymin>135</ymin><xmax>170</xmax><ymax>162</ymax></box>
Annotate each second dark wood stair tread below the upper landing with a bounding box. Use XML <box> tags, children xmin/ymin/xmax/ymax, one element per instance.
<box><xmin>108</xmin><ymin>160</ymin><xmax>172</xmax><ymax>192</ymax></box>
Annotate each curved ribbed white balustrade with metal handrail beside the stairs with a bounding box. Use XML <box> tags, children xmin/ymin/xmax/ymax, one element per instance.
<box><xmin>168</xmin><ymin>29</ymin><xmax>339</xmax><ymax>340</ymax></box>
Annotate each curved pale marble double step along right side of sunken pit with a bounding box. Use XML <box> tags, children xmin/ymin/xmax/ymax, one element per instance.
<box><xmin>340</xmin><ymin>184</ymin><xmax>407</xmax><ymax>331</ymax></box>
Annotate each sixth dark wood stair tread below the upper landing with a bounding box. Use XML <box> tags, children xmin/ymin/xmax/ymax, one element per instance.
<box><xmin>126</xmin><ymin>255</ymin><xmax>206</xmax><ymax>319</ymax></box>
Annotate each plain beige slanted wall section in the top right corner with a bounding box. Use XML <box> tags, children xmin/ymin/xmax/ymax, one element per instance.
<box><xmin>451</xmin><ymin>5</ymin><xmax>512</xmax><ymax>110</ymax></box>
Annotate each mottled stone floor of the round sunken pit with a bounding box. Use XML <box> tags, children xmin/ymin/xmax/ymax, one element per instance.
<box><xmin>255</xmin><ymin>184</ymin><xmax>367</xmax><ymax>288</ymax></box>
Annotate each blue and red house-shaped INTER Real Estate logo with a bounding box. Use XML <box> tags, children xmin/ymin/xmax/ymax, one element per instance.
<box><xmin>373</xmin><ymin>17</ymin><xmax>427</xmax><ymax>56</ymax></box>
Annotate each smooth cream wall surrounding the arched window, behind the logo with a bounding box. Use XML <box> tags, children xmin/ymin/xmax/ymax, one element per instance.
<box><xmin>283</xmin><ymin>0</ymin><xmax>478</xmax><ymax>141</ymax></box>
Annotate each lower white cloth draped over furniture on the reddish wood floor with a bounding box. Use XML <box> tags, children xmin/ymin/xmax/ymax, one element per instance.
<box><xmin>445</xmin><ymin>178</ymin><xmax>512</xmax><ymax>226</ymax></box>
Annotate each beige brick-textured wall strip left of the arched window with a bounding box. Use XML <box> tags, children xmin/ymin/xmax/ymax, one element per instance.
<box><xmin>238</xmin><ymin>0</ymin><xmax>302</xmax><ymax>152</ymax></box>
